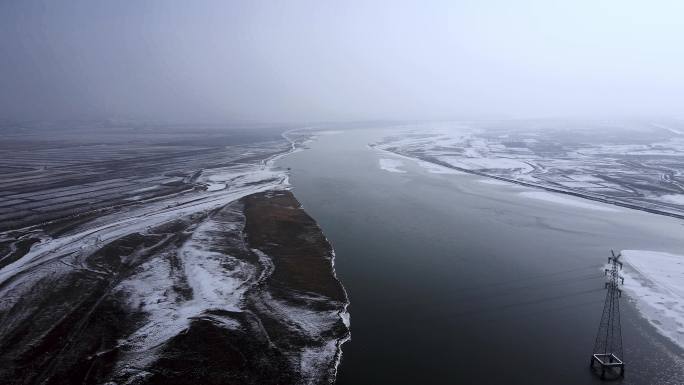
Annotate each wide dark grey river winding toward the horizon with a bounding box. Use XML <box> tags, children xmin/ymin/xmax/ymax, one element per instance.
<box><xmin>279</xmin><ymin>129</ymin><xmax>684</xmax><ymax>385</ymax></box>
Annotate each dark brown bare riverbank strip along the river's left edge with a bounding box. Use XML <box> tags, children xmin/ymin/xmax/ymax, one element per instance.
<box><xmin>243</xmin><ymin>191</ymin><xmax>350</xmax><ymax>383</ymax></box>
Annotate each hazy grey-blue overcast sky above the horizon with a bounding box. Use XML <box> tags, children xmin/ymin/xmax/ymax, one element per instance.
<box><xmin>0</xmin><ymin>0</ymin><xmax>684</xmax><ymax>121</ymax></box>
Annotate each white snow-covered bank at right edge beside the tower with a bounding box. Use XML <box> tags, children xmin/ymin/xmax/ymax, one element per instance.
<box><xmin>621</xmin><ymin>250</ymin><xmax>684</xmax><ymax>348</ymax></box>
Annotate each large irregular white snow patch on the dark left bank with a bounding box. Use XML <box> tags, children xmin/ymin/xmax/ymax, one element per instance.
<box><xmin>117</xmin><ymin>210</ymin><xmax>256</xmax><ymax>356</ymax></box>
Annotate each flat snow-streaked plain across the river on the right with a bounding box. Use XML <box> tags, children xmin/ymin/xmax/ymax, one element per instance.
<box><xmin>371</xmin><ymin>121</ymin><xmax>684</xmax><ymax>218</ymax></box>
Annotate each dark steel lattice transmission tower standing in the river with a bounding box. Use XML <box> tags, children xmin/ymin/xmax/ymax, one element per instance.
<box><xmin>590</xmin><ymin>250</ymin><xmax>625</xmax><ymax>378</ymax></box>
